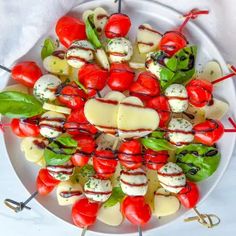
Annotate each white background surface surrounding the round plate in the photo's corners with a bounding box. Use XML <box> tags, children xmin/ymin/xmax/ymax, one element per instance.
<box><xmin>0</xmin><ymin>0</ymin><xmax>236</xmax><ymax>236</ymax></box>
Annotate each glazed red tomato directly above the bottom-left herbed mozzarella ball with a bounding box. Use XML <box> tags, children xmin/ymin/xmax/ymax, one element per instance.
<box><xmin>93</xmin><ymin>150</ymin><xmax>117</xmax><ymax>179</ymax></box>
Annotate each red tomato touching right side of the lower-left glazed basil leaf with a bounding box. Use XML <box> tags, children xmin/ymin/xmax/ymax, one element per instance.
<box><xmin>71</xmin><ymin>133</ymin><xmax>96</xmax><ymax>167</ymax></box>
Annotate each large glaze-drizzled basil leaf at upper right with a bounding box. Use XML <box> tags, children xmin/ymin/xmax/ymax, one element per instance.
<box><xmin>160</xmin><ymin>46</ymin><xmax>197</xmax><ymax>89</ymax></box>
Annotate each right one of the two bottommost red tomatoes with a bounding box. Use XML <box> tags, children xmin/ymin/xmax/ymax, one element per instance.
<box><xmin>121</xmin><ymin>196</ymin><xmax>152</xmax><ymax>226</ymax></box>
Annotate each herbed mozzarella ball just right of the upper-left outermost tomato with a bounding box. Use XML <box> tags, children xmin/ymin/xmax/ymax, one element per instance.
<box><xmin>33</xmin><ymin>74</ymin><xmax>62</xmax><ymax>101</ymax></box>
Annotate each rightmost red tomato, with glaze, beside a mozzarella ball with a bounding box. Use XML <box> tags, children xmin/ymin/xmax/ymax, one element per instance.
<box><xmin>193</xmin><ymin>120</ymin><xmax>224</xmax><ymax>146</ymax></box>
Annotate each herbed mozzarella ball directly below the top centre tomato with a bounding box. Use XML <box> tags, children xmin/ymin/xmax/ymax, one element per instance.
<box><xmin>107</xmin><ymin>38</ymin><xmax>133</xmax><ymax>63</ymax></box>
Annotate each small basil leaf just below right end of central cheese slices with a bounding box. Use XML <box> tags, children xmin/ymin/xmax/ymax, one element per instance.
<box><xmin>141</xmin><ymin>137</ymin><xmax>175</xmax><ymax>151</ymax></box>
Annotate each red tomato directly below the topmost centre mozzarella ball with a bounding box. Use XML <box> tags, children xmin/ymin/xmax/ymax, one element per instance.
<box><xmin>107</xmin><ymin>63</ymin><xmax>135</xmax><ymax>92</ymax></box>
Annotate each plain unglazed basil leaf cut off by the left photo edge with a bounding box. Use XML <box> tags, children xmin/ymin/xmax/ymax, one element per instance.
<box><xmin>0</xmin><ymin>91</ymin><xmax>43</xmax><ymax>118</ymax></box>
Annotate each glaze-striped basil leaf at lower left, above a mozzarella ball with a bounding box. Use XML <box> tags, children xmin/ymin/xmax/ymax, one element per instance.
<box><xmin>44</xmin><ymin>136</ymin><xmax>78</xmax><ymax>165</ymax></box>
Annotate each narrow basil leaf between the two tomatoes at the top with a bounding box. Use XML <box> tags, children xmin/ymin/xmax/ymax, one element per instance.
<box><xmin>85</xmin><ymin>17</ymin><xmax>102</xmax><ymax>48</ymax></box>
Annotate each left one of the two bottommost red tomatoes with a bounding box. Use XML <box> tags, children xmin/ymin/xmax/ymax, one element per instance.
<box><xmin>72</xmin><ymin>198</ymin><xmax>99</xmax><ymax>228</ymax></box>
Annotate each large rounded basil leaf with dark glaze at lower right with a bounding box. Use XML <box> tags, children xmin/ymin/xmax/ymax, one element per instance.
<box><xmin>176</xmin><ymin>144</ymin><xmax>220</xmax><ymax>182</ymax></box>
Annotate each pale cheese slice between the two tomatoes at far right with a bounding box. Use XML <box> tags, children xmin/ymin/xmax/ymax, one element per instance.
<box><xmin>204</xmin><ymin>98</ymin><xmax>229</xmax><ymax>120</ymax></box>
